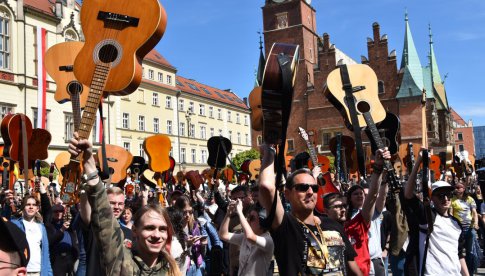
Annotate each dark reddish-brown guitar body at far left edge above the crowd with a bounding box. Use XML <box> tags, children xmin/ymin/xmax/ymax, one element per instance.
<box><xmin>2</xmin><ymin>114</ymin><xmax>32</xmax><ymax>169</ymax></box>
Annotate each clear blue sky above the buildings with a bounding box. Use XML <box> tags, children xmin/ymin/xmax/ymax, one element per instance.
<box><xmin>156</xmin><ymin>0</ymin><xmax>485</xmax><ymax>126</ymax></box>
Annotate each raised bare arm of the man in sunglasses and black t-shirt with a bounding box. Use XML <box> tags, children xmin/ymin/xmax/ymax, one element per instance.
<box><xmin>259</xmin><ymin>144</ymin><xmax>285</xmax><ymax>230</ymax></box>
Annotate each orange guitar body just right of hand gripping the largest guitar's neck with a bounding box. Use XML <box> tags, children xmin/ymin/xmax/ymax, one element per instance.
<box><xmin>97</xmin><ymin>144</ymin><xmax>133</xmax><ymax>184</ymax></box>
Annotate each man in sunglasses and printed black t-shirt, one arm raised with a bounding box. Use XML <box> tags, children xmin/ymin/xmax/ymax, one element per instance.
<box><xmin>259</xmin><ymin>144</ymin><xmax>362</xmax><ymax>276</ymax></box>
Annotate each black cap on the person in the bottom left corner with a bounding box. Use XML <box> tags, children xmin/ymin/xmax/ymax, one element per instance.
<box><xmin>0</xmin><ymin>218</ymin><xmax>30</xmax><ymax>267</ymax></box>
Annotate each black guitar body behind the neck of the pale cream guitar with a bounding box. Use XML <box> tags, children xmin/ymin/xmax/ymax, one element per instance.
<box><xmin>365</xmin><ymin>112</ymin><xmax>400</xmax><ymax>154</ymax></box>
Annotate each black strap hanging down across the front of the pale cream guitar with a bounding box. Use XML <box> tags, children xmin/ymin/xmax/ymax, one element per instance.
<box><xmin>339</xmin><ymin>64</ymin><xmax>367</xmax><ymax>179</ymax></box>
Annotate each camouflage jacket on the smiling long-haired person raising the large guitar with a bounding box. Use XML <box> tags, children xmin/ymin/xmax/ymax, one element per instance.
<box><xmin>85</xmin><ymin>180</ymin><xmax>168</xmax><ymax>276</ymax></box>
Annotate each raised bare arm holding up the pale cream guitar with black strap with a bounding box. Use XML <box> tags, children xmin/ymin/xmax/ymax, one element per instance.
<box><xmin>362</xmin><ymin>149</ymin><xmax>391</xmax><ymax>223</ymax></box>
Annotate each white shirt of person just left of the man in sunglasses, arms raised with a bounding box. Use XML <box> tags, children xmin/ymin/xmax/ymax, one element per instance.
<box><xmin>229</xmin><ymin>232</ymin><xmax>274</xmax><ymax>275</ymax></box>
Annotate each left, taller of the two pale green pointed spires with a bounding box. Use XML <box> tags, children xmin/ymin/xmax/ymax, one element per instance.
<box><xmin>401</xmin><ymin>11</ymin><xmax>423</xmax><ymax>89</ymax></box>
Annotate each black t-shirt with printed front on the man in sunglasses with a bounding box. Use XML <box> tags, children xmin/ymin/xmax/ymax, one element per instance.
<box><xmin>271</xmin><ymin>213</ymin><xmax>357</xmax><ymax>276</ymax></box>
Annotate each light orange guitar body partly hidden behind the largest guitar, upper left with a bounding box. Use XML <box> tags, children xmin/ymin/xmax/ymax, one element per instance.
<box><xmin>44</xmin><ymin>41</ymin><xmax>89</xmax><ymax>108</ymax></box>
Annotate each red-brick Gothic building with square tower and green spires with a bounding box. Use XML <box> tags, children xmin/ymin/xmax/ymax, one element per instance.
<box><xmin>252</xmin><ymin>0</ymin><xmax>453</xmax><ymax>160</ymax></box>
